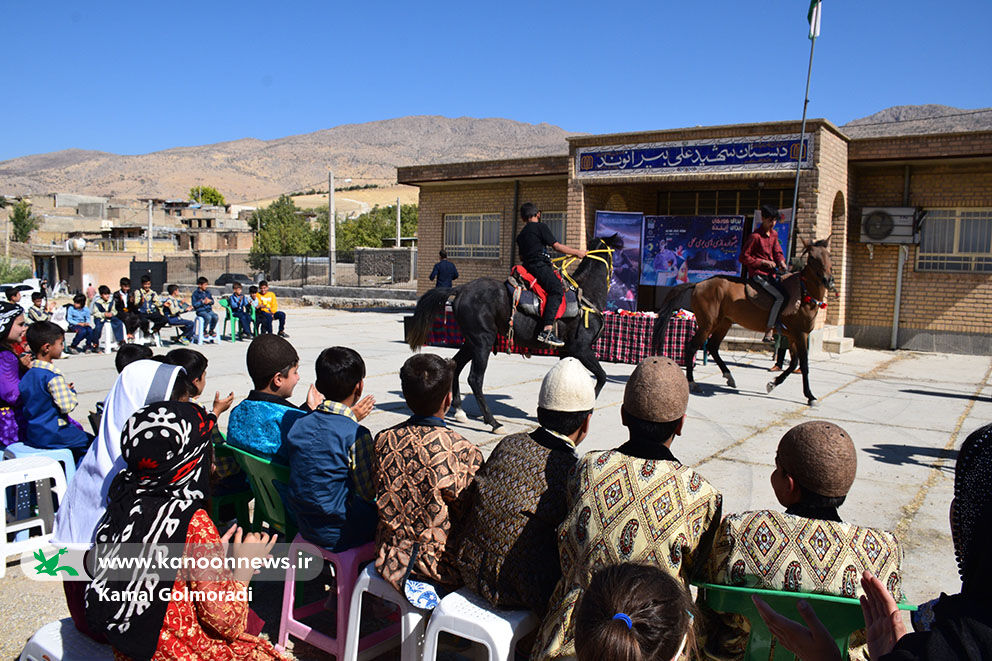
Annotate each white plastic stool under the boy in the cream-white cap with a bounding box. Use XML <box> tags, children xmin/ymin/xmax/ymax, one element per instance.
<box><xmin>422</xmin><ymin>588</ymin><xmax>540</xmax><ymax>661</ymax></box>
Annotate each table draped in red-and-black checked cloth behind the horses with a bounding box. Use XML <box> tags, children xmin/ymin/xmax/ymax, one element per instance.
<box><xmin>418</xmin><ymin>307</ymin><xmax>696</xmax><ymax>365</ymax></box>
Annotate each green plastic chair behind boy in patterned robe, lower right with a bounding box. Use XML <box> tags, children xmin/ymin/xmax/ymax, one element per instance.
<box><xmin>697</xmin><ymin>583</ymin><xmax>915</xmax><ymax>661</ymax></box>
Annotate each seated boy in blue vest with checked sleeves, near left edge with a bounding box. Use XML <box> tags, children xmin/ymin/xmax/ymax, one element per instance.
<box><xmin>20</xmin><ymin>321</ymin><xmax>93</xmax><ymax>461</ymax></box>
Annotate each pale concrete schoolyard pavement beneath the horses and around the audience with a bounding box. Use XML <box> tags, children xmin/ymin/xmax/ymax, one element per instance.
<box><xmin>0</xmin><ymin>308</ymin><xmax>992</xmax><ymax>659</ymax></box>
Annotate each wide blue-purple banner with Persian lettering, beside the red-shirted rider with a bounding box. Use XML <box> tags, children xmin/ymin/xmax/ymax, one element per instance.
<box><xmin>640</xmin><ymin>216</ymin><xmax>744</xmax><ymax>287</ymax></box>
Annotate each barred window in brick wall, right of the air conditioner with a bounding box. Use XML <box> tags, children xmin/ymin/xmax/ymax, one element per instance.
<box><xmin>916</xmin><ymin>209</ymin><xmax>992</xmax><ymax>273</ymax></box>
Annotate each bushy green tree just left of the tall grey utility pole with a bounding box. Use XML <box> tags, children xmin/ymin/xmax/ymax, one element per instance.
<box><xmin>248</xmin><ymin>195</ymin><xmax>327</xmax><ymax>270</ymax></box>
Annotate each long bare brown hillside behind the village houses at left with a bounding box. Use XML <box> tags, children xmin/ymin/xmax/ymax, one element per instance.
<box><xmin>0</xmin><ymin>116</ymin><xmax>570</xmax><ymax>202</ymax></box>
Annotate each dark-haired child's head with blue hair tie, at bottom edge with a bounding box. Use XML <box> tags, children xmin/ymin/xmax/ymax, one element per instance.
<box><xmin>575</xmin><ymin>562</ymin><xmax>696</xmax><ymax>661</ymax></box>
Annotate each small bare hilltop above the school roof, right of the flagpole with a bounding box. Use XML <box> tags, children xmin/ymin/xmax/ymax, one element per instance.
<box><xmin>841</xmin><ymin>104</ymin><xmax>992</xmax><ymax>138</ymax></box>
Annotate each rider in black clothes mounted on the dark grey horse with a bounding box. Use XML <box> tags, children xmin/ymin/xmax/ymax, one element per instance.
<box><xmin>517</xmin><ymin>202</ymin><xmax>586</xmax><ymax>347</ymax></box>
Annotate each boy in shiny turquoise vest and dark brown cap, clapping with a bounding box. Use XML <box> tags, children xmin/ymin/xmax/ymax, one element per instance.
<box><xmin>227</xmin><ymin>335</ymin><xmax>306</xmax><ymax>464</ymax></box>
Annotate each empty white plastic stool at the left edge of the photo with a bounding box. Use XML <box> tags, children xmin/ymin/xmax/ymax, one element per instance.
<box><xmin>0</xmin><ymin>455</ymin><xmax>66</xmax><ymax>578</ymax></box>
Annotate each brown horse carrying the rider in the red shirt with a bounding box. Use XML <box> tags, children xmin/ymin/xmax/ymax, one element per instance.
<box><xmin>654</xmin><ymin>237</ymin><xmax>834</xmax><ymax>406</ymax></box>
